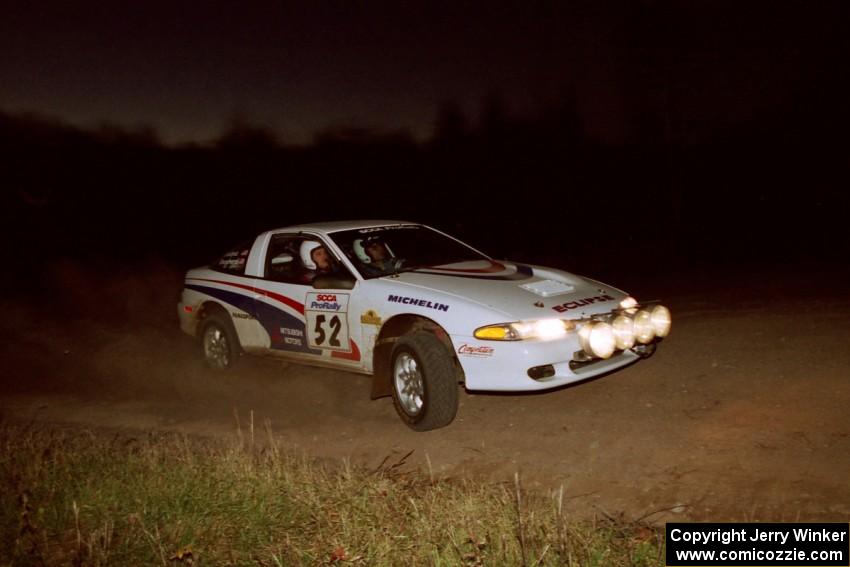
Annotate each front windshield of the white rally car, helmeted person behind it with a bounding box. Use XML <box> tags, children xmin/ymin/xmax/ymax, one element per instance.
<box><xmin>330</xmin><ymin>224</ymin><xmax>489</xmax><ymax>279</ymax></box>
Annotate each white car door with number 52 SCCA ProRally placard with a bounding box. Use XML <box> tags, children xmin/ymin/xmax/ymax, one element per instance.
<box><xmin>248</xmin><ymin>233</ymin><xmax>362</xmax><ymax>369</ymax></box>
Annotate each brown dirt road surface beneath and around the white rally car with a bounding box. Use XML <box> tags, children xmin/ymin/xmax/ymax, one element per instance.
<box><xmin>0</xmin><ymin>266</ymin><xmax>850</xmax><ymax>522</ymax></box>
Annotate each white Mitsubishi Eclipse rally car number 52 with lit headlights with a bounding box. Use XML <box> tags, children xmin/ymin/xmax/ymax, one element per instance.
<box><xmin>178</xmin><ymin>221</ymin><xmax>670</xmax><ymax>430</ymax></box>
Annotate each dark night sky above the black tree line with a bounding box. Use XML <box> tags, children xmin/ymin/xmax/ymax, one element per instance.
<box><xmin>0</xmin><ymin>1</ymin><xmax>847</xmax><ymax>143</ymax></box>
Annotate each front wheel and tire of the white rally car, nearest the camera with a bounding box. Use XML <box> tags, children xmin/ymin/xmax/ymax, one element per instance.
<box><xmin>390</xmin><ymin>331</ymin><xmax>458</xmax><ymax>431</ymax></box>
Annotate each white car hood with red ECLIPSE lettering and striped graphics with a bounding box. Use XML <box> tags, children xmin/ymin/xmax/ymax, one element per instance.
<box><xmin>385</xmin><ymin>260</ymin><xmax>626</xmax><ymax>320</ymax></box>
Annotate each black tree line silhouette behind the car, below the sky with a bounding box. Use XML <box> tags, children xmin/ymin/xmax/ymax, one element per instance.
<box><xmin>0</xmin><ymin>85</ymin><xmax>848</xmax><ymax>292</ymax></box>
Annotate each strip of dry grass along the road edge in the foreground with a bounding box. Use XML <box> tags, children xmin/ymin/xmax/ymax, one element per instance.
<box><xmin>0</xmin><ymin>426</ymin><xmax>663</xmax><ymax>566</ymax></box>
